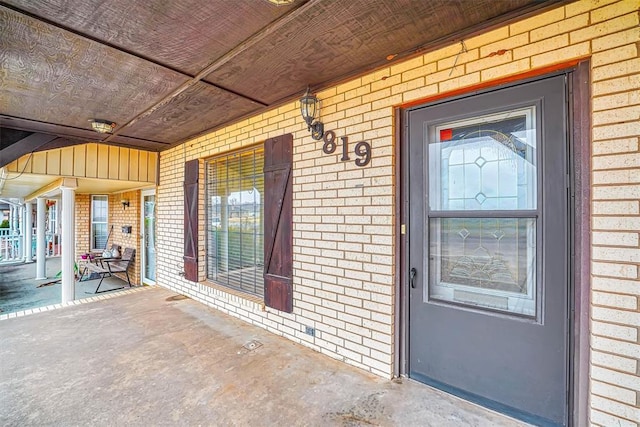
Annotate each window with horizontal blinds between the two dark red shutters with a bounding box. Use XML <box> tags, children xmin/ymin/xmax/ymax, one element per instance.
<box><xmin>206</xmin><ymin>146</ymin><xmax>264</xmax><ymax>296</ymax></box>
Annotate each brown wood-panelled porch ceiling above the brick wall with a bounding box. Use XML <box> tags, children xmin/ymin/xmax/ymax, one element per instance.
<box><xmin>0</xmin><ymin>0</ymin><xmax>561</xmax><ymax>166</ymax></box>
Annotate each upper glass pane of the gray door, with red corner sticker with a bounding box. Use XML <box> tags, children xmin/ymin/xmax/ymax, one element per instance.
<box><xmin>429</xmin><ymin>107</ymin><xmax>537</xmax><ymax>211</ymax></box>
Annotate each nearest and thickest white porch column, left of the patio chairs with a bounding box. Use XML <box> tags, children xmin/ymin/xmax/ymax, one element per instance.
<box><xmin>58</xmin><ymin>179</ymin><xmax>77</xmax><ymax>304</ymax></box>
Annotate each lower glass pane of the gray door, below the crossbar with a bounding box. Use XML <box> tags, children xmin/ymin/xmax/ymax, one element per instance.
<box><xmin>429</xmin><ymin>218</ymin><xmax>536</xmax><ymax>316</ymax></box>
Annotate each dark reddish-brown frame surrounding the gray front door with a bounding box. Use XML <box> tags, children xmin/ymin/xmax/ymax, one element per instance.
<box><xmin>394</xmin><ymin>59</ymin><xmax>591</xmax><ymax>426</ymax></box>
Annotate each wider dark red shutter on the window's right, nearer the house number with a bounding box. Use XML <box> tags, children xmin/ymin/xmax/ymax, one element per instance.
<box><xmin>264</xmin><ymin>134</ymin><xmax>293</xmax><ymax>313</ymax></box>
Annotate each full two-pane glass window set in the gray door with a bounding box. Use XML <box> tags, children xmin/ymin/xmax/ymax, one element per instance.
<box><xmin>426</xmin><ymin>106</ymin><xmax>539</xmax><ymax>317</ymax></box>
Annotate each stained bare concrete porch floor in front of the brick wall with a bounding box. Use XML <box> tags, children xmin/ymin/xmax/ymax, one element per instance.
<box><xmin>0</xmin><ymin>287</ymin><xmax>526</xmax><ymax>427</ymax></box>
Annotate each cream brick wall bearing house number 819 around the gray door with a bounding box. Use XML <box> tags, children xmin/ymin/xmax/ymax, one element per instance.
<box><xmin>158</xmin><ymin>0</ymin><xmax>640</xmax><ymax>426</ymax></box>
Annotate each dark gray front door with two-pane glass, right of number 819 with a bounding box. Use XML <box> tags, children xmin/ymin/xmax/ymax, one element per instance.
<box><xmin>408</xmin><ymin>76</ymin><xmax>569</xmax><ymax>425</ymax></box>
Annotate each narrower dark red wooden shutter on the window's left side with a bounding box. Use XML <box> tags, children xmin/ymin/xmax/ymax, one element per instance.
<box><xmin>183</xmin><ymin>159</ymin><xmax>199</xmax><ymax>282</ymax></box>
